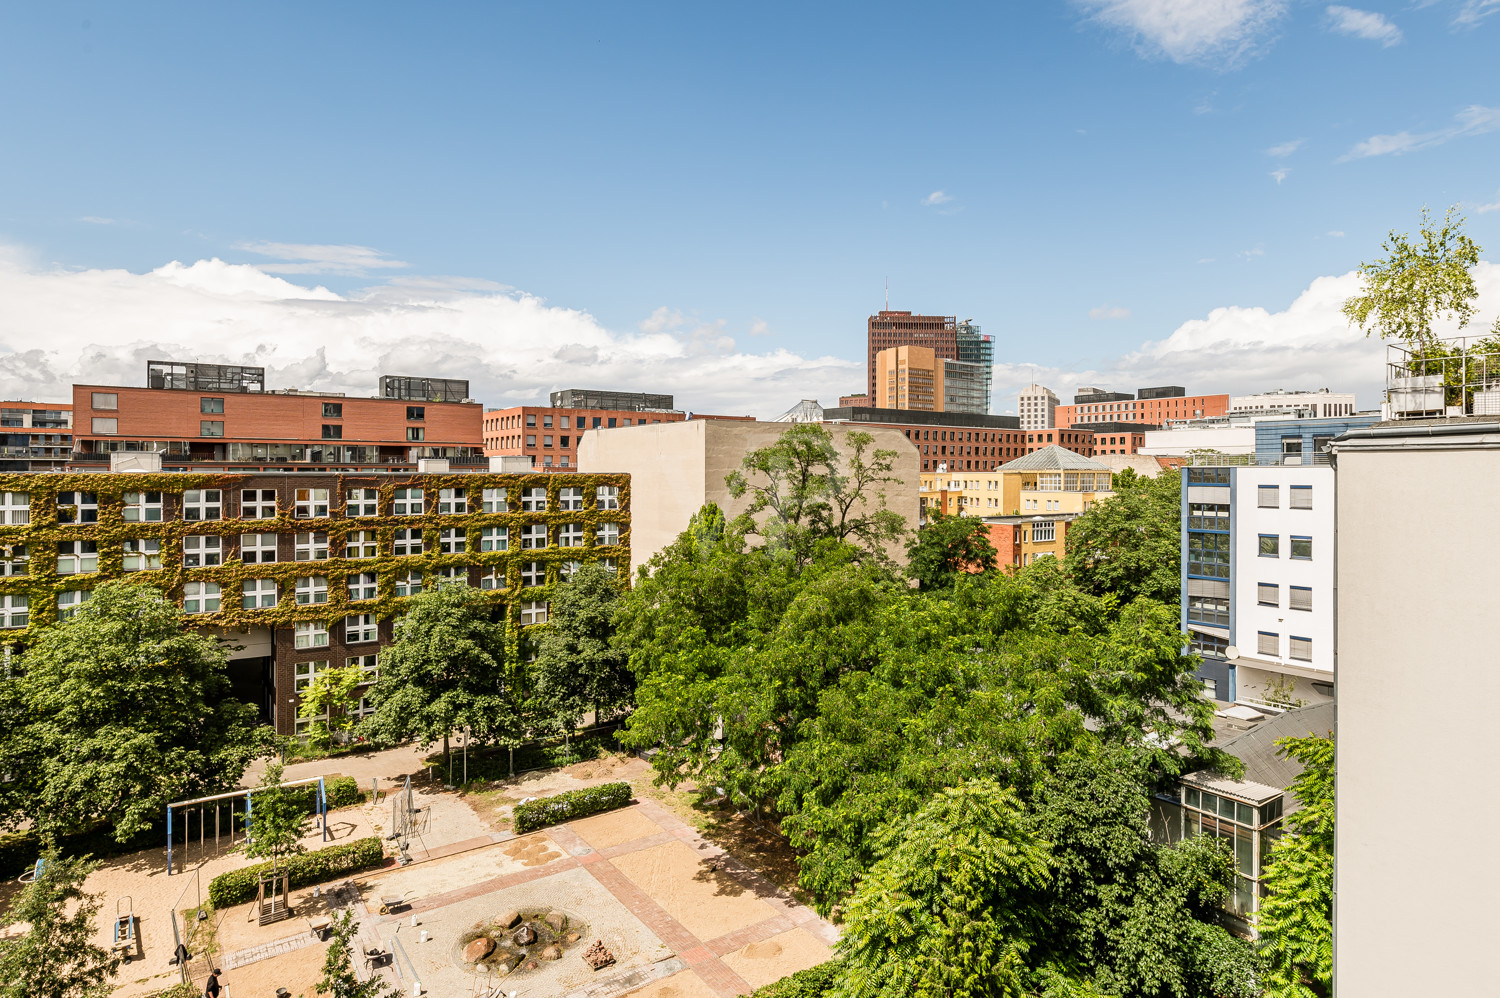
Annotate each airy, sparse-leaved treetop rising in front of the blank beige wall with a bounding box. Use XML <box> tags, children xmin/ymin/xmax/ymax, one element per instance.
<box><xmin>725</xmin><ymin>423</ymin><xmax>906</xmax><ymax>566</ymax></box>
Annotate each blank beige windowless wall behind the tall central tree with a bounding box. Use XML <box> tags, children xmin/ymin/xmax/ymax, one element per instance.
<box><xmin>578</xmin><ymin>419</ymin><xmax>921</xmax><ymax>573</ymax></box>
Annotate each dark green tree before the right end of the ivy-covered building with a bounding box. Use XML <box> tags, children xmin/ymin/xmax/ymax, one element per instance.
<box><xmin>531</xmin><ymin>564</ymin><xmax>636</xmax><ymax>729</ymax></box>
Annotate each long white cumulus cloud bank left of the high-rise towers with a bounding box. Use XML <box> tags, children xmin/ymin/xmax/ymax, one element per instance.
<box><xmin>0</xmin><ymin>253</ymin><xmax>864</xmax><ymax>417</ymax></box>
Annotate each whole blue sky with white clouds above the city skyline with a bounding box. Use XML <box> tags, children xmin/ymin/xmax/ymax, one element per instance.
<box><xmin>0</xmin><ymin>0</ymin><xmax>1500</xmax><ymax>416</ymax></box>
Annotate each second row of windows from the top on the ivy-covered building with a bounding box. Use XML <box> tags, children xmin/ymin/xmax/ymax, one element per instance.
<box><xmin>30</xmin><ymin>524</ymin><xmax>620</xmax><ymax>576</ymax></box>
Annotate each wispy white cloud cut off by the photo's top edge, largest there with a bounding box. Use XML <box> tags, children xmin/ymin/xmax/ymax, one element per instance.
<box><xmin>1074</xmin><ymin>0</ymin><xmax>1287</xmax><ymax>69</ymax></box>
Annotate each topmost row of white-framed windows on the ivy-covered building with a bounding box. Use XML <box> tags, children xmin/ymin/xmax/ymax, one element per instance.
<box><xmin>0</xmin><ymin>485</ymin><xmax>620</xmax><ymax>525</ymax></box>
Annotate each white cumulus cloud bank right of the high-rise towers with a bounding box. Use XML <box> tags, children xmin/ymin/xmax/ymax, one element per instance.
<box><xmin>995</xmin><ymin>263</ymin><xmax>1500</xmax><ymax>408</ymax></box>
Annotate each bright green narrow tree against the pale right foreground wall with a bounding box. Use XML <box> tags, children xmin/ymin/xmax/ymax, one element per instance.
<box><xmin>1256</xmin><ymin>735</ymin><xmax>1334</xmax><ymax>998</ymax></box>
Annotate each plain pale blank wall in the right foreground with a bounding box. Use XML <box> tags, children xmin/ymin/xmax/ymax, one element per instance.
<box><xmin>1335</xmin><ymin>435</ymin><xmax>1500</xmax><ymax>998</ymax></box>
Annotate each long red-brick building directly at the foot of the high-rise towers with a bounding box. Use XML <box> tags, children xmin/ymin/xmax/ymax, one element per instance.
<box><xmin>824</xmin><ymin>407</ymin><xmax>1095</xmax><ymax>471</ymax></box>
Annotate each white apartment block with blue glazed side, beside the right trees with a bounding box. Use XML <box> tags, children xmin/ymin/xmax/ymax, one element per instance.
<box><xmin>1182</xmin><ymin>464</ymin><xmax>1334</xmax><ymax>707</ymax></box>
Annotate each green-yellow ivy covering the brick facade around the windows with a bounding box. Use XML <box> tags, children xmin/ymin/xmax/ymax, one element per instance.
<box><xmin>0</xmin><ymin>473</ymin><xmax>630</xmax><ymax>644</ymax></box>
